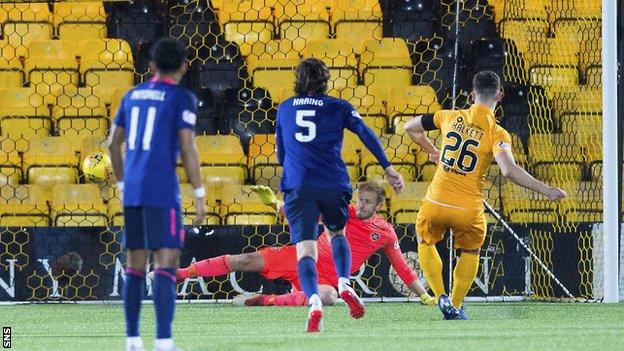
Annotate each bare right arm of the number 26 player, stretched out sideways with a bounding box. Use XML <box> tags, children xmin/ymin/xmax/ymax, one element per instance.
<box><xmin>494</xmin><ymin>148</ymin><xmax>568</xmax><ymax>201</ymax></box>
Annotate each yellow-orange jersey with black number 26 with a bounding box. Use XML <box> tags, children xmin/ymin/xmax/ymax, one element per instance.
<box><xmin>427</xmin><ymin>104</ymin><xmax>511</xmax><ymax>207</ymax></box>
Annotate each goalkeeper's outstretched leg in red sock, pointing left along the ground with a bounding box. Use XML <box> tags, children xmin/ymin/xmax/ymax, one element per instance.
<box><xmin>176</xmin><ymin>252</ymin><xmax>264</xmax><ymax>281</ymax></box>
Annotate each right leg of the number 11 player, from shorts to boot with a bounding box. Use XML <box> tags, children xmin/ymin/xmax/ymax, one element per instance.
<box><xmin>144</xmin><ymin>207</ymin><xmax>184</xmax><ymax>351</ymax></box>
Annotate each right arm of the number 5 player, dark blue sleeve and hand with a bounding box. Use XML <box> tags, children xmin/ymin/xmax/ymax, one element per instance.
<box><xmin>345</xmin><ymin>105</ymin><xmax>405</xmax><ymax>193</ymax></box>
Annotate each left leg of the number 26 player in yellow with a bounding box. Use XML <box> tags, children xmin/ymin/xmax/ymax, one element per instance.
<box><xmin>416</xmin><ymin>201</ymin><xmax>448</xmax><ymax>299</ymax></box>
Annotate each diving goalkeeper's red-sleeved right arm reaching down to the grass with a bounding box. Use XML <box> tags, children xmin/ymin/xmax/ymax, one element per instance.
<box><xmin>384</xmin><ymin>230</ymin><xmax>435</xmax><ymax>306</ymax></box>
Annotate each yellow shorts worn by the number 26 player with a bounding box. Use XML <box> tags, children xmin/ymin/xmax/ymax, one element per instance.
<box><xmin>416</xmin><ymin>200</ymin><xmax>486</xmax><ymax>250</ymax></box>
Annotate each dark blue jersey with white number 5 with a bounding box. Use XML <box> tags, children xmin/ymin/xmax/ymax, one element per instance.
<box><xmin>275</xmin><ymin>94</ymin><xmax>364</xmax><ymax>191</ymax></box>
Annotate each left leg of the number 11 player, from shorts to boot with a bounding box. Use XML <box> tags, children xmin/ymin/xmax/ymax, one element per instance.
<box><xmin>123</xmin><ymin>207</ymin><xmax>148</xmax><ymax>351</ymax></box>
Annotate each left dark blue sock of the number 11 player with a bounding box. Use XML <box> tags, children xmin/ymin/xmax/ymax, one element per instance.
<box><xmin>123</xmin><ymin>267</ymin><xmax>145</xmax><ymax>337</ymax></box>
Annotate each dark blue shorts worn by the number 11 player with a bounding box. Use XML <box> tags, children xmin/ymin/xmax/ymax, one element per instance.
<box><xmin>123</xmin><ymin>207</ymin><xmax>185</xmax><ymax>251</ymax></box>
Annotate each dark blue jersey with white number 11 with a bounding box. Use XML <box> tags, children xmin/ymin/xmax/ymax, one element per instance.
<box><xmin>114</xmin><ymin>80</ymin><xmax>197</xmax><ymax>208</ymax></box>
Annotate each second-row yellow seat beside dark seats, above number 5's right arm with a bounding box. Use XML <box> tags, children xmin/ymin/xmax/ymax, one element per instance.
<box><xmin>360</xmin><ymin>38</ymin><xmax>412</xmax><ymax>68</ymax></box>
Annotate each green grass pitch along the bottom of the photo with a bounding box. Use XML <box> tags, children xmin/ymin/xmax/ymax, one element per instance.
<box><xmin>0</xmin><ymin>303</ymin><xmax>624</xmax><ymax>351</ymax></box>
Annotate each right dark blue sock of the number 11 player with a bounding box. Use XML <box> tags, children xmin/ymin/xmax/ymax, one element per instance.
<box><xmin>152</xmin><ymin>268</ymin><xmax>176</xmax><ymax>339</ymax></box>
